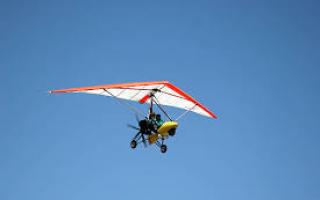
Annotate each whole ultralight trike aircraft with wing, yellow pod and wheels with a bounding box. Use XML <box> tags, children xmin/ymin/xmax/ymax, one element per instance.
<box><xmin>50</xmin><ymin>81</ymin><xmax>217</xmax><ymax>153</ymax></box>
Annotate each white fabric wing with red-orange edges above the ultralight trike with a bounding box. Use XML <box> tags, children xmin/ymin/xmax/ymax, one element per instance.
<box><xmin>50</xmin><ymin>81</ymin><xmax>217</xmax><ymax>118</ymax></box>
